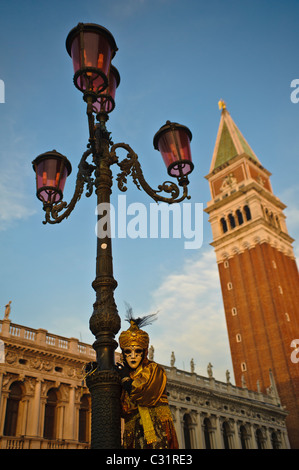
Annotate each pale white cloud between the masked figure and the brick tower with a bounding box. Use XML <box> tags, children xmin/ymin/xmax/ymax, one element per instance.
<box><xmin>149</xmin><ymin>248</ymin><xmax>236</xmax><ymax>380</ymax></box>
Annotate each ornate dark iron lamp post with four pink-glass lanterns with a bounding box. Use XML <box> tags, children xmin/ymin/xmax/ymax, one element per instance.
<box><xmin>32</xmin><ymin>23</ymin><xmax>193</xmax><ymax>449</ymax></box>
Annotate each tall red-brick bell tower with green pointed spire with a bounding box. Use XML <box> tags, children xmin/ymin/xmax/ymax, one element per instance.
<box><xmin>205</xmin><ymin>101</ymin><xmax>299</xmax><ymax>448</ymax></box>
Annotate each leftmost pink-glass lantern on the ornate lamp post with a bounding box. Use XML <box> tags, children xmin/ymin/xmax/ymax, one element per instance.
<box><xmin>32</xmin><ymin>150</ymin><xmax>72</xmax><ymax>204</ymax></box>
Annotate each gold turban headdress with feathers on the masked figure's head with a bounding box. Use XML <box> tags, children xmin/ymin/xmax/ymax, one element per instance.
<box><xmin>119</xmin><ymin>304</ymin><xmax>157</xmax><ymax>349</ymax></box>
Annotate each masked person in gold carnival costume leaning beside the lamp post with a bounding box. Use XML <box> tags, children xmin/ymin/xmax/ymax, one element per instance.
<box><xmin>116</xmin><ymin>307</ymin><xmax>178</xmax><ymax>449</ymax></box>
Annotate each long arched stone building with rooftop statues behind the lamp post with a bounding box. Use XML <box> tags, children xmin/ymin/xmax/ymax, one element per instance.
<box><xmin>0</xmin><ymin>318</ymin><xmax>289</xmax><ymax>449</ymax></box>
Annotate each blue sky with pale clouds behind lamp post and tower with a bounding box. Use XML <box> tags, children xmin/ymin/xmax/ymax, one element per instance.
<box><xmin>0</xmin><ymin>0</ymin><xmax>299</xmax><ymax>380</ymax></box>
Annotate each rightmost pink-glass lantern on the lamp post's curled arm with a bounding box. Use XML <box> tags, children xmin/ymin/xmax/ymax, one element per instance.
<box><xmin>154</xmin><ymin>121</ymin><xmax>194</xmax><ymax>180</ymax></box>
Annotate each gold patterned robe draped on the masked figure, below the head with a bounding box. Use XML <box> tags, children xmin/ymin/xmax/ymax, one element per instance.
<box><xmin>121</xmin><ymin>359</ymin><xmax>178</xmax><ymax>449</ymax></box>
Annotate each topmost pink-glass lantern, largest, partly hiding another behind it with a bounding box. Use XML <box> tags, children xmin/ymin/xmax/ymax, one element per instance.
<box><xmin>66</xmin><ymin>23</ymin><xmax>117</xmax><ymax>94</ymax></box>
